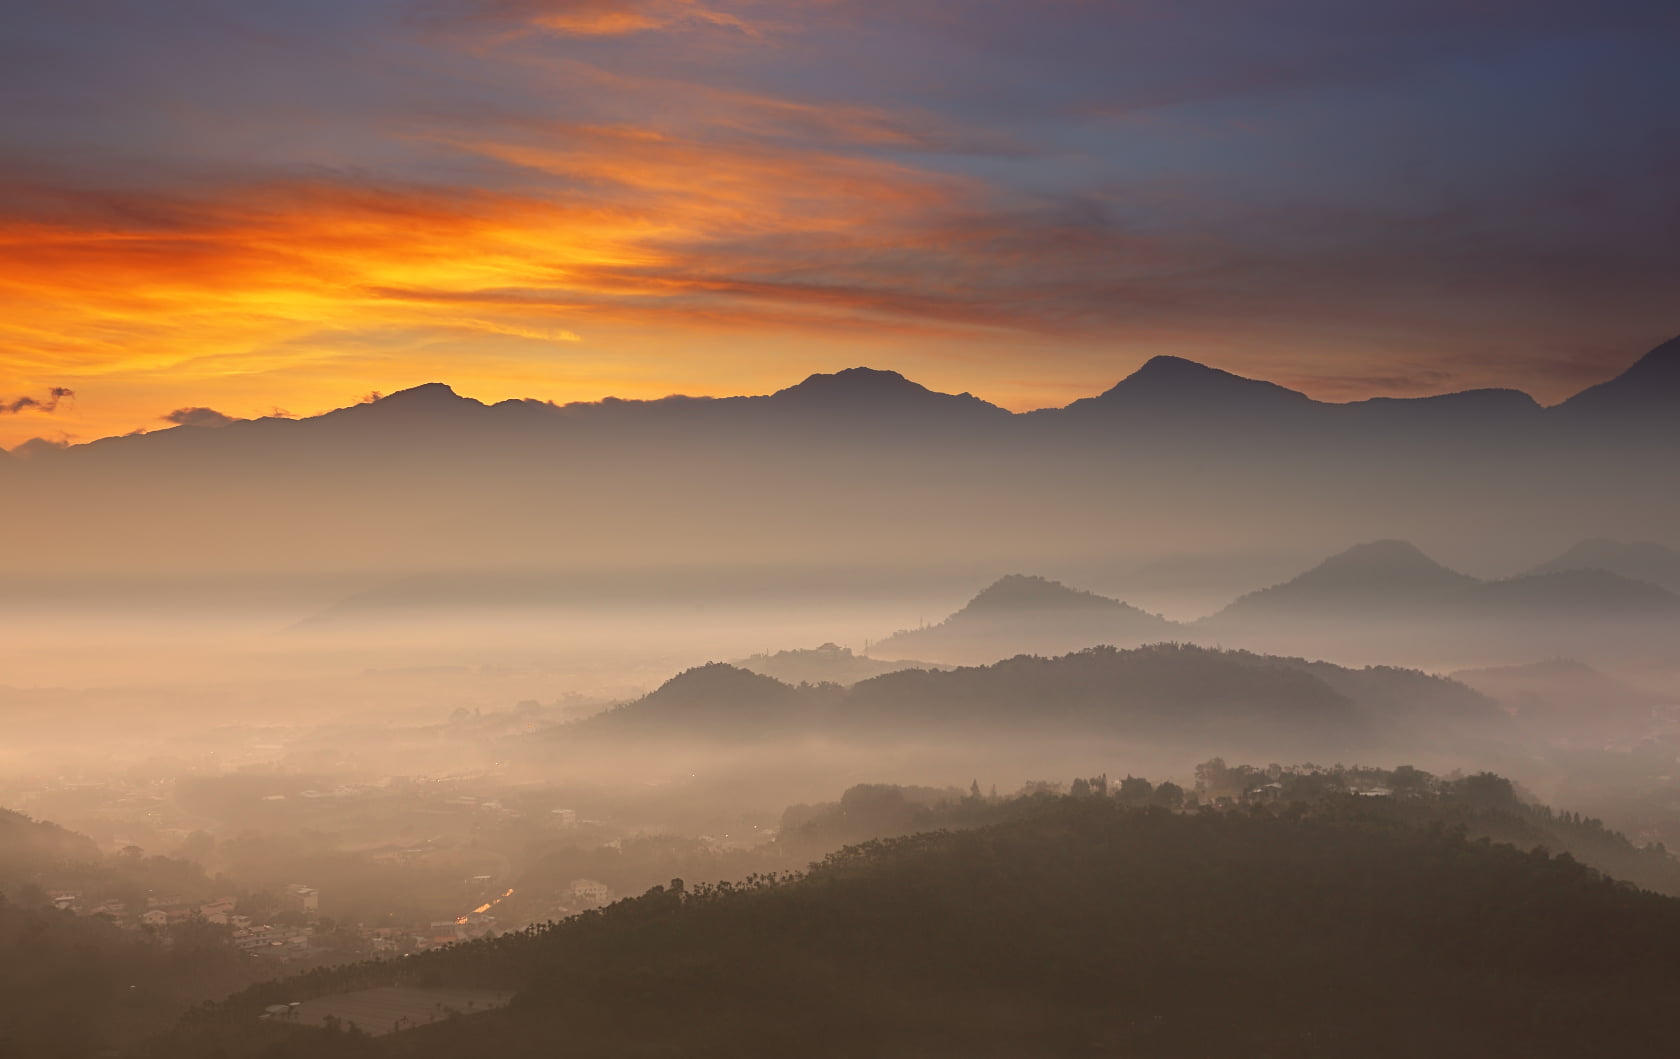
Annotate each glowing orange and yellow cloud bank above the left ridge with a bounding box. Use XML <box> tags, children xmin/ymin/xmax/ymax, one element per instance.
<box><xmin>0</xmin><ymin>111</ymin><xmax>1048</xmax><ymax>444</ymax></box>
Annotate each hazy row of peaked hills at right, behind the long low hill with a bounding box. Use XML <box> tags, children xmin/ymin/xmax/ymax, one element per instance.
<box><xmin>872</xmin><ymin>540</ymin><xmax>1680</xmax><ymax>662</ymax></box>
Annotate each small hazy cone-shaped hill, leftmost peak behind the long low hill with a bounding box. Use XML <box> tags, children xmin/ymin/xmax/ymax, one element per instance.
<box><xmin>870</xmin><ymin>573</ymin><xmax>1178</xmax><ymax>662</ymax></box>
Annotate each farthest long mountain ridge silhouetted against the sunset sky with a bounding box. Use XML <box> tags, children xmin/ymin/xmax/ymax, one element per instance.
<box><xmin>0</xmin><ymin>343</ymin><xmax>1680</xmax><ymax>581</ymax></box>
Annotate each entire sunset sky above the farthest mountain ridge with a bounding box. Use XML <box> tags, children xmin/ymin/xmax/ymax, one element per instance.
<box><xmin>0</xmin><ymin>0</ymin><xmax>1680</xmax><ymax>447</ymax></box>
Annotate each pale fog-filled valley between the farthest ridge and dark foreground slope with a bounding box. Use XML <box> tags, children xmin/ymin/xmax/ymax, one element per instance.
<box><xmin>0</xmin><ymin>351</ymin><xmax>1680</xmax><ymax>1047</ymax></box>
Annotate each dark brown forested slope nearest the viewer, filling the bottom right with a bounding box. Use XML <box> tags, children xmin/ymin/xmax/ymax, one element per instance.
<box><xmin>146</xmin><ymin>795</ymin><xmax>1680</xmax><ymax>1059</ymax></box>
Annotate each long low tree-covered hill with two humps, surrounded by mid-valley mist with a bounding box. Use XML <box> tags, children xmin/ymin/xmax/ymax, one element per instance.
<box><xmin>564</xmin><ymin>644</ymin><xmax>1505</xmax><ymax>753</ymax></box>
